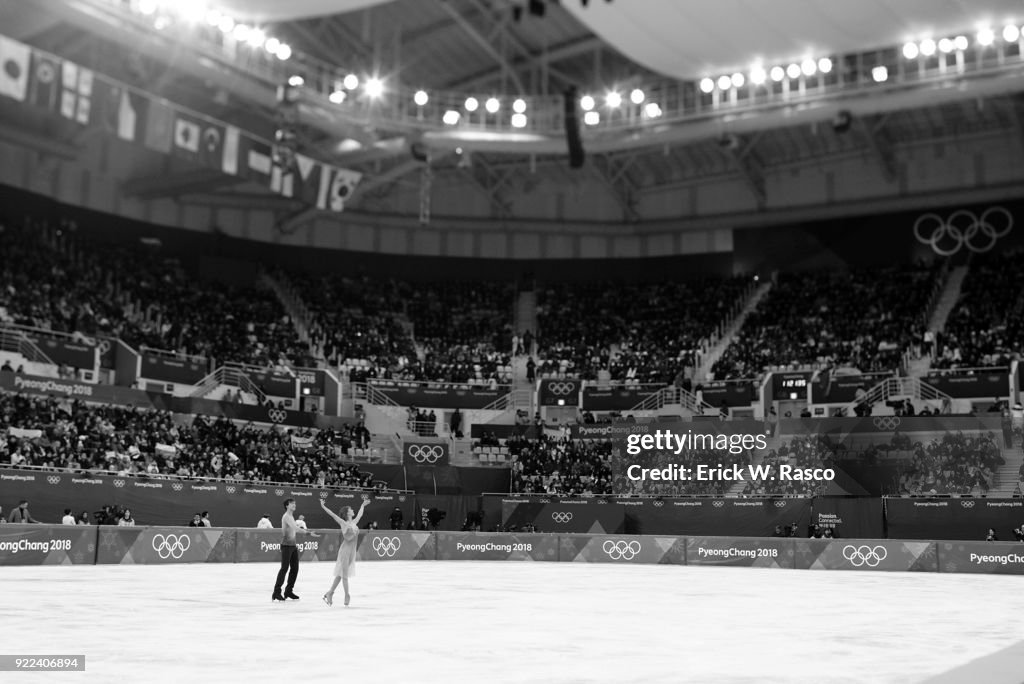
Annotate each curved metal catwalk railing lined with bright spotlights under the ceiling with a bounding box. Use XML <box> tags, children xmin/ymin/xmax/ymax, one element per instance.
<box><xmin>81</xmin><ymin>0</ymin><xmax>1024</xmax><ymax>138</ymax></box>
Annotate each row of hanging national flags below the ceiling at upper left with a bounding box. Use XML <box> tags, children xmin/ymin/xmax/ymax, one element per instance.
<box><xmin>0</xmin><ymin>35</ymin><xmax>362</xmax><ymax>212</ymax></box>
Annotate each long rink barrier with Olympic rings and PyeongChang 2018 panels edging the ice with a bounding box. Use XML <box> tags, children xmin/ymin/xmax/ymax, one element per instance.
<box><xmin>0</xmin><ymin>524</ymin><xmax>1024</xmax><ymax>574</ymax></box>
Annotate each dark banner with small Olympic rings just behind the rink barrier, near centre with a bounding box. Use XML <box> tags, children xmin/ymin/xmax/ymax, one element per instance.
<box><xmin>493</xmin><ymin>497</ymin><xmax>624</xmax><ymax>533</ymax></box>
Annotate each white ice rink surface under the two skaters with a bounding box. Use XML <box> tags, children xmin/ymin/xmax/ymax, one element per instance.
<box><xmin>0</xmin><ymin>561</ymin><xmax>1024</xmax><ymax>684</ymax></box>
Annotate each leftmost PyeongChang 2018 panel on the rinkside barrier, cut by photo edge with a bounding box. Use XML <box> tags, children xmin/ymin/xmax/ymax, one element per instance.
<box><xmin>0</xmin><ymin>523</ymin><xmax>96</xmax><ymax>565</ymax></box>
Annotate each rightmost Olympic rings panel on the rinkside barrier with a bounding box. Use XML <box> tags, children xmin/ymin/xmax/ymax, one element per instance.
<box><xmin>795</xmin><ymin>540</ymin><xmax>938</xmax><ymax>572</ymax></box>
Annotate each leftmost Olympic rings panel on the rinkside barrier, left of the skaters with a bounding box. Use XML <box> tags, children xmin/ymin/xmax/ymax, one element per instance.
<box><xmin>96</xmin><ymin>526</ymin><xmax>234</xmax><ymax>564</ymax></box>
